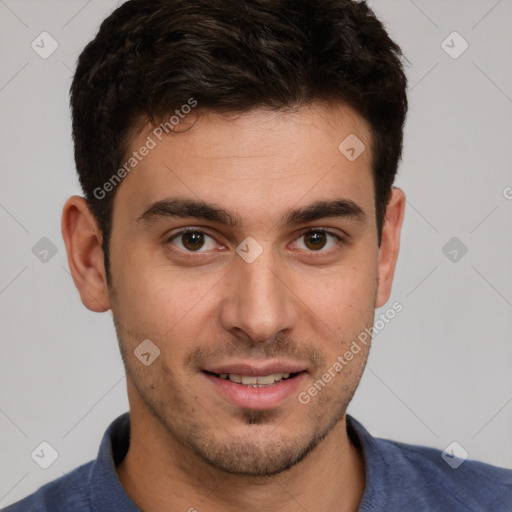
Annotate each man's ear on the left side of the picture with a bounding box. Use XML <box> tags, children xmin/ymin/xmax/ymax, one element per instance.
<box><xmin>62</xmin><ymin>196</ymin><xmax>110</xmax><ymax>313</ymax></box>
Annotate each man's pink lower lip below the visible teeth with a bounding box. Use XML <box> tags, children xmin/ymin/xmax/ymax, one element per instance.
<box><xmin>203</xmin><ymin>372</ymin><xmax>306</xmax><ymax>410</ymax></box>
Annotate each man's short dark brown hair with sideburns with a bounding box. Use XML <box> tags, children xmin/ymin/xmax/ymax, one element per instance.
<box><xmin>71</xmin><ymin>0</ymin><xmax>407</xmax><ymax>271</ymax></box>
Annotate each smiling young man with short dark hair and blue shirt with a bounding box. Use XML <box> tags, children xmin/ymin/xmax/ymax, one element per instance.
<box><xmin>6</xmin><ymin>0</ymin><xmax>512</xmax><ymax>512</ymax></box>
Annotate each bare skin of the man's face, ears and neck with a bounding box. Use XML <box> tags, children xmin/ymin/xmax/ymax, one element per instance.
<box><xmin>63</xmin><ymin>104</ymin><xmax>405</xmax><ymax>512</ymax></box>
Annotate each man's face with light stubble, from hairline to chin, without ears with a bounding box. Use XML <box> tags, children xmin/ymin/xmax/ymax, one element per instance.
<box><xmin>109</xmin><ymin>105</ymin><xmax>379</xmax><ymax>475</ymax></box>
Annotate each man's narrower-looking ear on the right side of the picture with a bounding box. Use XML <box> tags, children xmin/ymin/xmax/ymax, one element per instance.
<box><xmin>375</xmin><ymin>187</ymin><xmax>405</xmax><ymax>308</ymax></box>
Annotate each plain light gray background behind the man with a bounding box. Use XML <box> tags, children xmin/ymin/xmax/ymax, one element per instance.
<box><xmin>0</xmin><ymin>0</ymin><xmax>512</xmax><ymax>507</ymax></box>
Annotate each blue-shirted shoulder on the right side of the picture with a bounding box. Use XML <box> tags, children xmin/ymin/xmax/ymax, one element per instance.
<box><xmin>348</xmin><ymin>418</ymin><xmax>512</xmax><ymax>512</ymax></box>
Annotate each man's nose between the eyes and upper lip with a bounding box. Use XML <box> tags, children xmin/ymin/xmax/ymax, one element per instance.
<box><xmin>220</xmin><ymin>245</ymin><xmax>298</xmax><ymax>342</ymax></box>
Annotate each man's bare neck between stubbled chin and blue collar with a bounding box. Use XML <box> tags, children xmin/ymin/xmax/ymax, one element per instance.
<box><xmin>117</xmin><ymin>411</ymin><xmax>365</xmax><ymax>512</ymax></box>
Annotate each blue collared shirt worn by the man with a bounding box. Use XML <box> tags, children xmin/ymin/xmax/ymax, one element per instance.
<box><xmin>4</xmin><ymin>413</ymin><xmax>512</xmax><ymax>512</ymax></box>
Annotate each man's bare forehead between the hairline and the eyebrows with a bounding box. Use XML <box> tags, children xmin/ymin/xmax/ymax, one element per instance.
<box><xmin>114</xmin><ymin>105</ymin><xmax>374</xmax><ymax>225</ymax></box>
